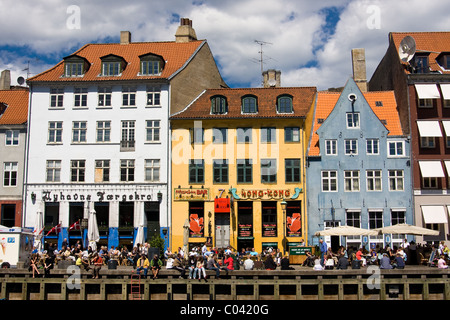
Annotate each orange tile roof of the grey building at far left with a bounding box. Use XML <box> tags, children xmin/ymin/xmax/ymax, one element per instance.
<box><xmin>0</xmin><ymin>88</ymin><xmax>28</xmax><ymax>125</ymax></box>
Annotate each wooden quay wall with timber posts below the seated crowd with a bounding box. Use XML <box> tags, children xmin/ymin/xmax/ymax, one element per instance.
<box><xmin>0</xmin><ymin>266</ymin><xmax>450</xmax><ymax>300</ymax></box>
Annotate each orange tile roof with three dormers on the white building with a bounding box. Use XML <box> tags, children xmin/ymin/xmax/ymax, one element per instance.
<box><xmin>28</xmin><ymin>40</ymin><xmax>206</xmax><ymax>82</ymax></box>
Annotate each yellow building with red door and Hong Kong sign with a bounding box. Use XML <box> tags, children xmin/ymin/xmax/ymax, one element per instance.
<box><xmin>170</xmin><ymin>87</ymin><xmax>316</xmax><ymax>252</ymax></box>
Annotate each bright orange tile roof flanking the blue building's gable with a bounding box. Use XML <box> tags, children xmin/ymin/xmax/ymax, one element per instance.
<box><xmin>308</xmin><ymin>91</ymin><xmax>403</xmax><ymax>156</ymax></box>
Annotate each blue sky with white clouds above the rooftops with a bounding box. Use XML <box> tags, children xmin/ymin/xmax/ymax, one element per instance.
<box><xmin>0</xmin><ymin>0</ymin><xmax>450</xmax><ymax>90</ymax></box>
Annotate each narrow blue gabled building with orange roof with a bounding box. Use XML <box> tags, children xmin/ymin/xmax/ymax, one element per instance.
<box><xmin>306</xmin><ymin>78</ymin><xmax>413</xmax><ymax>250</ymax></box>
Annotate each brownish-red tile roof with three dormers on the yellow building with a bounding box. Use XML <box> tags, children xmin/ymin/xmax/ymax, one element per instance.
<box><xmin>171</xmin><ymin>87</ymin><xmax>317</xmax><ymax>120</ymax></box>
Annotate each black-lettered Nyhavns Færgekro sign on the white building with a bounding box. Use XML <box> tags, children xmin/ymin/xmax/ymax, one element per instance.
<box><xmin>42</xmin><ymin>191</ymin><xmax>156</xmax><ymax>202</ymax></box>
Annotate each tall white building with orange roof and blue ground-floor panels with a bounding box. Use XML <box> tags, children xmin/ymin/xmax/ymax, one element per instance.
<box><xmin>24</xmin><ymin>19</ymin><xmax>224</xmax><ymax>249</ymax></box>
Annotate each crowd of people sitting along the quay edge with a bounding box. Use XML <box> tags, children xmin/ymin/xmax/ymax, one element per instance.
<box><xmin>25</xmin><ymin>239</ymin><xmax>450</xmax><ymax>280</ymax></box>
